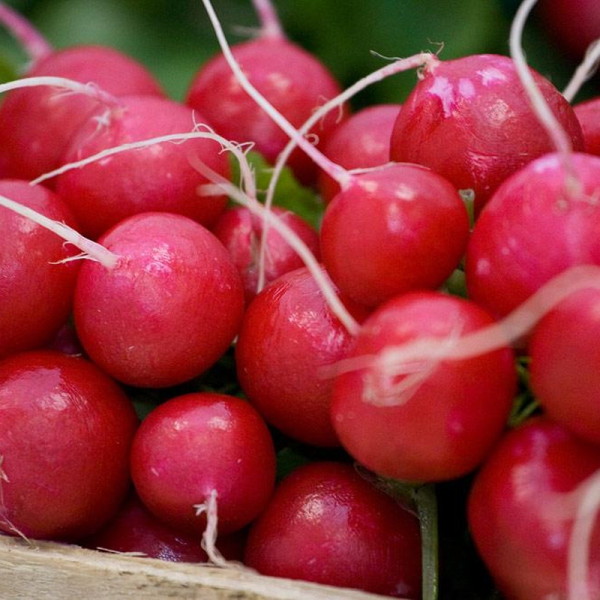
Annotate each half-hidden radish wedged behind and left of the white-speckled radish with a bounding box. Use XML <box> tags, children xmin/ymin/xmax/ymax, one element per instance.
<box><xmin>317</xmin><ymin>104</ymin><xmax>400</xmax><ymax>203</ymax></box>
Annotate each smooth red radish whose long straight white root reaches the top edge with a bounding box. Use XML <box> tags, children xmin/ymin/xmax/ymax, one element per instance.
<box><xmin>321</xmin><ymin>164</ymin><xmax>469</xmax><ymax>307</ymax></box>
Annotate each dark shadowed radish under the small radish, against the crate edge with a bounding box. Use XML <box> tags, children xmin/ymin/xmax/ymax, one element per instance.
<box><xmin>80</xmin><ymin>493</ymin><xmax>245</xmax><ymax>562</ymax></box>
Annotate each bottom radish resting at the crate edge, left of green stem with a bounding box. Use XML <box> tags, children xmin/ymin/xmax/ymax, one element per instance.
<box><xmin>244</xmin><ymin>462</ymin><xmax>421</xmax><ymax>598</ymax></box>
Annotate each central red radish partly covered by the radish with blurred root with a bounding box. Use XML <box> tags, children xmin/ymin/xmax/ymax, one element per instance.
<box><xmin>235</xmin><ymin>268</ymin><xmax>366</xmax><ymax>446</ymax></box>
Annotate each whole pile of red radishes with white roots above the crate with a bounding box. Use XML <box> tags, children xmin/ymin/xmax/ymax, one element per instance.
<box><xmin>0</xmin><ymin>0</ymin><xmax>600</xmax><ymax>600</ymax></box>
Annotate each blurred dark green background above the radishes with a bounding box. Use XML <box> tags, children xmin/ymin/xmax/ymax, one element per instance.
<box><xmin>0</xmin><ymin>0</ymin><xmax>599</xmax><ymax>107</ymax></box>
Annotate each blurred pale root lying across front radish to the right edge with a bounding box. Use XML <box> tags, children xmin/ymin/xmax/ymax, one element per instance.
<box><xmin>323</xmin><ymin>265</ymin><xmax>600</xmax><ymax>406</ymax></box>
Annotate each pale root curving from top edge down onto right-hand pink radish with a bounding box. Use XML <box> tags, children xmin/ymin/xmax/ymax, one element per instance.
<box><xmin>509</xmin><ymin>0</ymin><xmax>579</xmax><ymax>190</ymax></box>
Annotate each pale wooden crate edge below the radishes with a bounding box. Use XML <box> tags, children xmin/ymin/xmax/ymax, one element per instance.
<box><xmin>0</xmin><ymin>535</ymin><xmax>394</xmax><ymax>600</ymax></box>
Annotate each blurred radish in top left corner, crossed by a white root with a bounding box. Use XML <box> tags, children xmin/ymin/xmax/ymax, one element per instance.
<box><xmin>0</xmin><ymin>5</ymin><xmax>164</xmax><ymax>179</ymax></box>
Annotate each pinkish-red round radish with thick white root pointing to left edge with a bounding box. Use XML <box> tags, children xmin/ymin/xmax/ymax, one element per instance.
<box><xmin>74</xmin><ymin>213</ymin><xmax>244</xmax><ymax>387</ymax></box>
